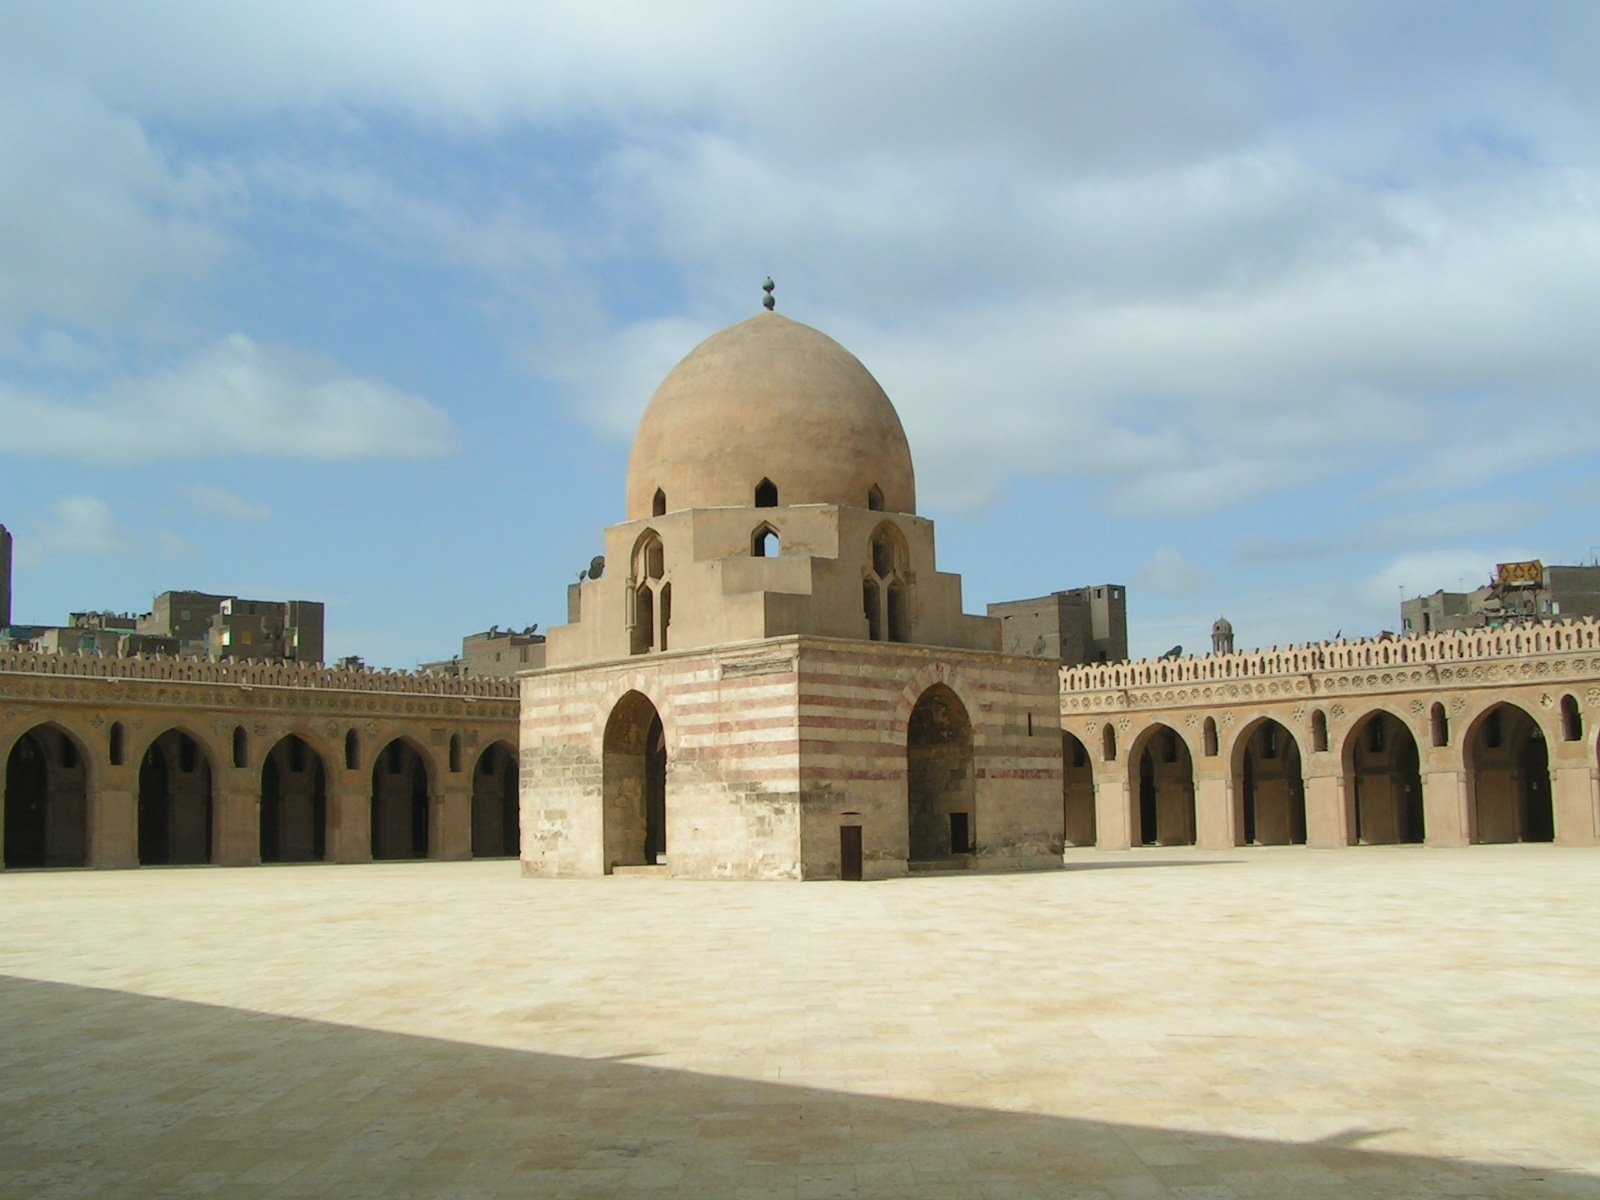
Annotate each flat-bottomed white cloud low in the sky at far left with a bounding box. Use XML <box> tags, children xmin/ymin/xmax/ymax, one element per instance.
<box><xmin>0</xmin><ymin>333</ymin><xmax>456</xmax><ymax>462</ymax></box>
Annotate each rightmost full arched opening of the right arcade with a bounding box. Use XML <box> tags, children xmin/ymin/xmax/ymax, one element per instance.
<box><xmin>1466</xmin><ymin>704</ymin><xmax>1555</xmax><ymax>842</ymax></box>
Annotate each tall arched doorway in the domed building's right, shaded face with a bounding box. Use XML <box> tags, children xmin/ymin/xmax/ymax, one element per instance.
<box><xmin>906</xmin><ymin>683</ymin><xmax>978</xmax><ymax>862</ymax></box>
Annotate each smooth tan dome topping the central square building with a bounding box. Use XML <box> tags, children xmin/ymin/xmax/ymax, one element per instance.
<box><xmin>627</xmin><ymin>312</ymin><xmax>917</xmax><ymax>520</ymax></box>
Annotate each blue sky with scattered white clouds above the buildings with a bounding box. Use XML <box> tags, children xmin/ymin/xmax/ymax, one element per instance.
<box><xmin>0</xmin><ymin>0</ymin><xmax>1600</xmax><ymax>667</ymax></box>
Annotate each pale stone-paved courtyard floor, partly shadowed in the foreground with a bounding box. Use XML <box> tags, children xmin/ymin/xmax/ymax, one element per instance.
<box><xmin>0</xmin><ymin>846</ymin><xmax>1600</xmax><ymax>1200</ymax></box>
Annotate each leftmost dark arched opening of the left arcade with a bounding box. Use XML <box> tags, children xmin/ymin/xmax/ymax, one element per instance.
<box><xmin>3</xmin><ymin>725</ymin><xmax>88</xmax><ymax>867</ymax></box>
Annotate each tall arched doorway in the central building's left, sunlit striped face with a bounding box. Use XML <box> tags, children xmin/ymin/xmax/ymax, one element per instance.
<box><xmin>600</xmin><ymin>691</ymin><xmax>667</xmax><ymax>874</ymax></box>
